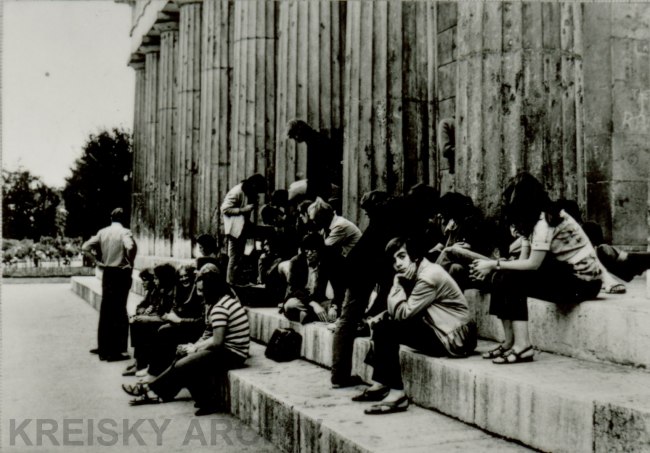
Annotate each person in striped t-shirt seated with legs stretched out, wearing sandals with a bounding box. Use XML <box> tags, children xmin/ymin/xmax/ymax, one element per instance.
<box><xmin>122</xmin><ymin>264</ymin><xmax>250</xmax><ymax>415</ymax></box>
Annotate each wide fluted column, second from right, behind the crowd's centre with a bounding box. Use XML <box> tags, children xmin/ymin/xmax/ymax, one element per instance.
<box><xmin>343</xmin><ymin>1</ymin><xmax>435</xmax><ymax>223</ymax></box>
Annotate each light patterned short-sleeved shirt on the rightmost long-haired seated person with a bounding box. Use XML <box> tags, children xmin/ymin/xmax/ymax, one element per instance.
<box><xmin>530</xmin><ymin>211</ymin><xmax>601</xmax><ymax>281</ymax></box>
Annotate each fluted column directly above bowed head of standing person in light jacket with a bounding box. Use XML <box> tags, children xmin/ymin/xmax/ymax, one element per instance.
<box><xmin>229</xmin><ymin>0</ymin><xmax>277</xmax><ymax>185</ymax></box>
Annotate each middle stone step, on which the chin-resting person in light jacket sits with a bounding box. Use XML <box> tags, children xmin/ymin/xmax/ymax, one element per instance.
<box><xmin>249</xmin><ymin>308</ymin><xmax>650</xmax><ymax>452</ymax></box>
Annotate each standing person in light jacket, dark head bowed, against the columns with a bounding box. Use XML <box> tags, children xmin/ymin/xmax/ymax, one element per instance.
<box><xmin>221</xmin><ymin>174</ymin><xmax>266</xmax><ymax>285</ymax></box>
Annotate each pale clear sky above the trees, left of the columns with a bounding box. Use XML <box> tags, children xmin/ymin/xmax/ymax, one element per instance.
<box><xmin>2</xmin><ymin>0</ymin><xmax>135</xmax><ymax>187</ymax></box>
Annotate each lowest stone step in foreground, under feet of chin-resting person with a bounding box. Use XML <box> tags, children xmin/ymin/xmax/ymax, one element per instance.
<box><xmin>228</xmin><ymin>344</ymin><xmax>531</xmax><ymax>453</ymax></box>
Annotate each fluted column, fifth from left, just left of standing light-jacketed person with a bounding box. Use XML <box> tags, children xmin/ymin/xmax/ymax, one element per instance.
<box><xmin>197</xmin><ymin>0</ymin><xmax>234</xmax><ymax>238</ymax></box>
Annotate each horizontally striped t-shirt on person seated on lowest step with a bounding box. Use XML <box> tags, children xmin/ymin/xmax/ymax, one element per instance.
<box><xmin>210</xmin><ymin>296</ymin><xmax>250</xmax><ymax>358</ymax></box>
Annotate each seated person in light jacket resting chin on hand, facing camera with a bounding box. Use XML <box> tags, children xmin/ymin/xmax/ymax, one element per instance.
<box><xmin>352</xmin><ymin>238</ymin><xmax>476</xmax><ymax>414</ymax></box>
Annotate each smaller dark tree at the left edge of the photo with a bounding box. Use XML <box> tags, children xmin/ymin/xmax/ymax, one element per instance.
<box><xmin>2</xmin><ymin>168</ymin><xmax>61</xmax><ymax>240</ymax></box>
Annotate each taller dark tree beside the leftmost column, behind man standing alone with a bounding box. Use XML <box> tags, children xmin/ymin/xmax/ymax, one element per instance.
<box><xmin>63</xmin><ymin>129</ymin><xmax>132</xmax><ymax>238</ymax></box>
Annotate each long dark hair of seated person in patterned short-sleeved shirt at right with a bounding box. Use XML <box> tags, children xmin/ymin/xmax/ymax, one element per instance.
<box><xmin>502</xmin><ymin>171</ymin><xmax>559</xmax><ymax>236</ymax></box>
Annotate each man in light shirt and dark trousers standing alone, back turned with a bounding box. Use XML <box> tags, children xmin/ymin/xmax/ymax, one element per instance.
<box><xmin>82</xmin><ymin>208</ymin><xmax>137</xmax><ymax>362</ymax></box>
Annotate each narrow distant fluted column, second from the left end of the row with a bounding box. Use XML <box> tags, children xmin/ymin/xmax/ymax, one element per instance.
<box><xmin>140</xmin><ymin>44</ymin><xmax>160</xmax><ymax>255</ymax></box>
